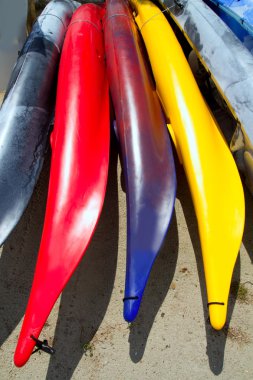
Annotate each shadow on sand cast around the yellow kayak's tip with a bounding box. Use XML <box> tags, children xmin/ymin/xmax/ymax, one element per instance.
<box><xmin>178</xmin><ymin>167</ymin><xmax>240</xmax><ymax>376</ymax></box>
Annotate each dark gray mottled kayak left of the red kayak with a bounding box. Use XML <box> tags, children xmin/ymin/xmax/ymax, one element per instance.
<box><xmin>0</xmin><ymin>0</ymin><xmax>76</xmax><ymax>244</ymax></box>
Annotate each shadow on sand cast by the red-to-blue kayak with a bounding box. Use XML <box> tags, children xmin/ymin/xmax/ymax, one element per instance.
<box><xmin>128</xmin><ymin>212</ymin><xmax>179</xmax><ymax>363</ymax></box>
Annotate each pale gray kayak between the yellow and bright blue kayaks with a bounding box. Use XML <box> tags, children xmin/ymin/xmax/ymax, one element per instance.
<box><xmin>159</xmin><ymin>0</ymin><xmax>253</xmax><ymax>192</ymax></box>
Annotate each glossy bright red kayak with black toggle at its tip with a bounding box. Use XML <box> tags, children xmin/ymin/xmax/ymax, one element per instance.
<box><xmin>14</xmin><ymin>4</ymin><xmax>110</xmax><ymax>367</ymax></box>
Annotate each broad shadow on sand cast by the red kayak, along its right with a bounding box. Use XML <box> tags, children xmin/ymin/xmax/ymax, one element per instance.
<box><xmin>46</xmin><ymin>139</ymin><xmax>119</xmax><ymax>380</ymax></box>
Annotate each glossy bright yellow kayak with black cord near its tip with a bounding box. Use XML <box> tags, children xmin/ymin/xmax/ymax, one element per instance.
<box><xmin>130</xmin><ymin>0</ymin><xmax>245</xmax><ymax>330</ymax></box>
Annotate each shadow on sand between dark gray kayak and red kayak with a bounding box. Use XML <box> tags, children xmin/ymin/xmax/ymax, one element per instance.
<box><xmin>0</xmin><ymin>154</ymin><xmax>51</xmax><ymax>346</ymax></box>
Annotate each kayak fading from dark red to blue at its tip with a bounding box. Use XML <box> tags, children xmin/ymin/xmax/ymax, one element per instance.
<box><xmin>104</xmin><ymin>0</ymin><xmax>176</xmax><ymax>322</ymax></box>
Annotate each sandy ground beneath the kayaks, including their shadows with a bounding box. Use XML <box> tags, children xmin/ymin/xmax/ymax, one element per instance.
<box><xmin>0</xmin><ymin>93</ymin><xmax>253</xmax><ymax>380</ymax></box>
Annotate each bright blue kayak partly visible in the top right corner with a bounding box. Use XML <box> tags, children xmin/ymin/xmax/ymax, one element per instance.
<box><xmin>204</xmin><ymin>0</ymin><xmax>253</xmax><ymax>53</ymax></box>
